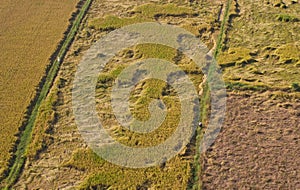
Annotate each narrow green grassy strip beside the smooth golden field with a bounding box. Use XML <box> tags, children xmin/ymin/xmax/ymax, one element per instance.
<box><xmin>2</xmin><ymin>0</ymin><xmax>92</xmax><ymax>188</ymax></box>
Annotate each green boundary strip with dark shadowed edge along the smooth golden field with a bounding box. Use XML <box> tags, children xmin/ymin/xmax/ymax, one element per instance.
<box><xmin>3</xmin><ymin>0</ymin><xmax>92</xmax><ymax>189</ymax></box>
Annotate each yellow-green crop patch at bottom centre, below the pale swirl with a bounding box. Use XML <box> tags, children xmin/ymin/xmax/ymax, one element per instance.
<box><xmin>65</xmin><ymin>150</ymin><xmax>190</xmax><ymax>189</ymax></box>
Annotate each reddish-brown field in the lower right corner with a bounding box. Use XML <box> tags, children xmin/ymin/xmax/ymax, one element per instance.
<box><xmin>202</xmin><ymin>92</ymin><xmax>300</xmax><ymax>189</ymax></box>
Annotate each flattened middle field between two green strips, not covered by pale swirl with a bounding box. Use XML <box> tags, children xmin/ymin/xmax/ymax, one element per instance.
<box><xmin>14</xmin><ymin>0</ymin><xmax>225</xmax><ymax>189</ymax></box>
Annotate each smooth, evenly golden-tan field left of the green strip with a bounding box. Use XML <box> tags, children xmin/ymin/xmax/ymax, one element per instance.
<box><xmin>0</xmin><ymin>0</ymin><xmax>78</xmax><ymax>178</ymax></box>
